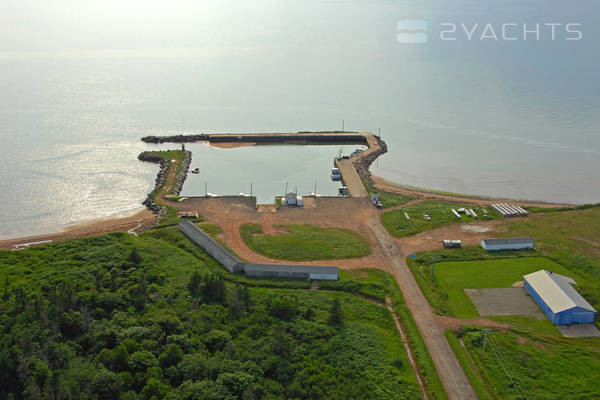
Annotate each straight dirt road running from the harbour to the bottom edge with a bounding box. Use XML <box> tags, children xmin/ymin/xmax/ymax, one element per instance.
<box><xmin>367</xmin><ymin>218</ymin><xmax>477</xmax><ymax>400</ymax></box>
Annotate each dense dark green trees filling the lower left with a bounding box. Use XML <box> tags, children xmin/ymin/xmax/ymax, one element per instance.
<box><xmin>0</xmin><ymin>235</ymin><xmax>414</xmax><ymax>400</ymax></box>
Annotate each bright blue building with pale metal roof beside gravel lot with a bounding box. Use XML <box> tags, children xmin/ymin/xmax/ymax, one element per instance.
<box><xmin>523</xmin><ymin>269</ymin><xmax>596</xmax><ymax>325</ymax></box>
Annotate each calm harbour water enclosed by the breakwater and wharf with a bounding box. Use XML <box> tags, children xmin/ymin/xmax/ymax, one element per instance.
<box><xmin>173</xmin><ymin>143</ymin><xmax>365</xmax><ymax>204</ymax></box>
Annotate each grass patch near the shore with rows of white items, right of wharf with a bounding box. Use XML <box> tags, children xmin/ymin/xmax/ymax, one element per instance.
<box><xmin>381</xmin><ymin>200</ymin><xmax>500</xmax><ymax>237</ymax></box>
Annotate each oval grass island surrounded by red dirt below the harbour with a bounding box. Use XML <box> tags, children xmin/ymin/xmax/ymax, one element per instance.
<box><xmin>240</xmin><ymin>223</ymin><xmax>371</xmax><ymax>261</ymax></box>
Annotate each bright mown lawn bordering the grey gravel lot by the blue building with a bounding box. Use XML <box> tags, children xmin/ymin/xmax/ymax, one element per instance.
<box><xmin>430</xmin><ymin>257</ymin><xmax>583</xmax><ymax>318</ymax></box>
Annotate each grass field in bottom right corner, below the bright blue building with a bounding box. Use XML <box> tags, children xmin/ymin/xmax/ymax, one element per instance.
<box><xmin>447</xmin><ymin>317</ymin><xmax>600</xmax><ymax>400</ymax></box>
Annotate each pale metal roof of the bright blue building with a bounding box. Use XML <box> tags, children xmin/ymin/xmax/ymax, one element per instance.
<box><xmin>523</xmin><ymin>269</ymin><xmax>596</xmax><ymax>314</ymax></box>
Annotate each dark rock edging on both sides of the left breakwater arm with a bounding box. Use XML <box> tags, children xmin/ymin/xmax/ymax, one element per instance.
<box><xmin>138</xmin><ymin>151</ymin><xmax>192</xmax><ymax>225</ymax></box>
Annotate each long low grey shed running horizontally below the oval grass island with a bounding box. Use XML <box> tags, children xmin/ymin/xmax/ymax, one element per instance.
<box><xmin>245</xmin><ymin>264</ymin><xmax>338</xmax><ymax>281</ymax></box>
